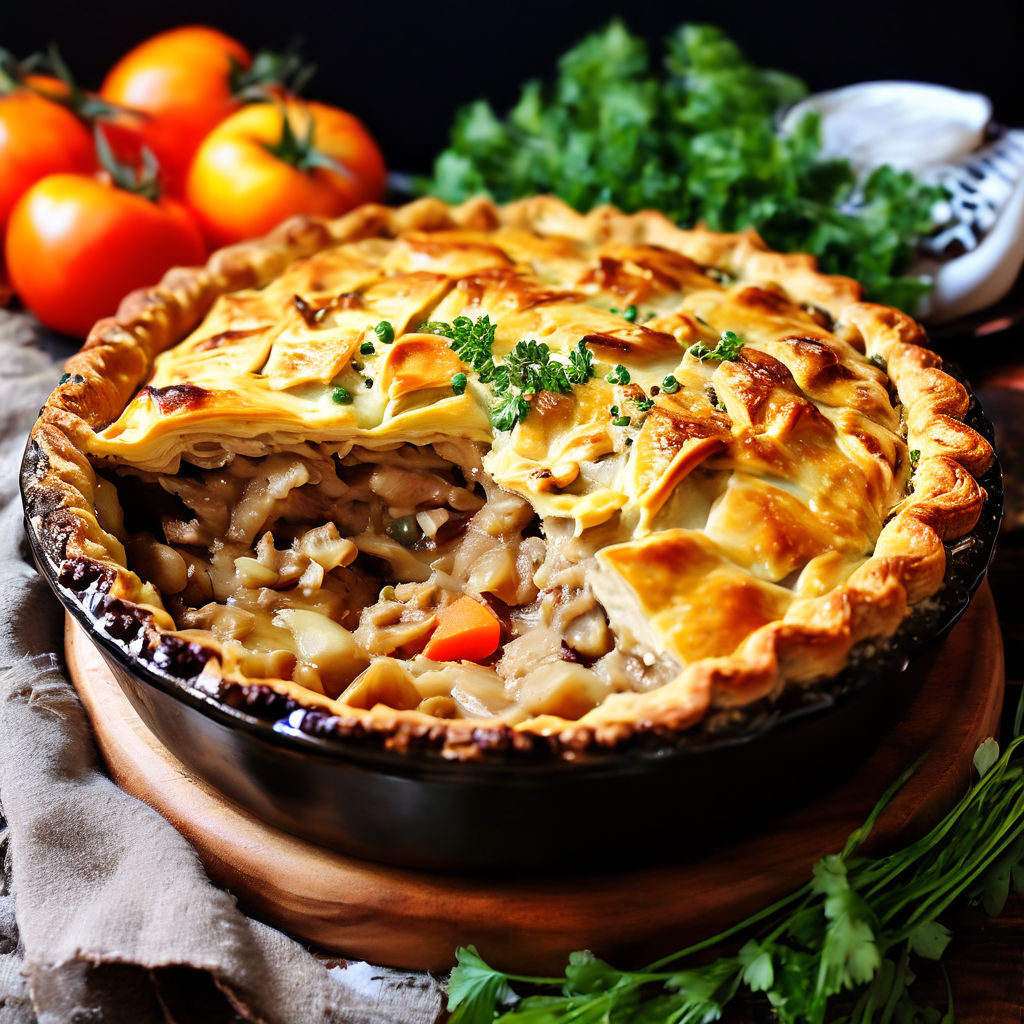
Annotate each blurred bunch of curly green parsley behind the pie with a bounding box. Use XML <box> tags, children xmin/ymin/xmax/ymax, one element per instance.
<box><xmin>420</xmin><ymin>22</ymin><xmax>942</xmax><ymax>310</ymax></box>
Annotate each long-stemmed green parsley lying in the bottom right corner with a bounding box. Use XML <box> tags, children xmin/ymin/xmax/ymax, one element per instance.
<box><xmin>449</xmin><ymin>709</ymin><xmax>1024</xmax><ymax>1024</ymax></box>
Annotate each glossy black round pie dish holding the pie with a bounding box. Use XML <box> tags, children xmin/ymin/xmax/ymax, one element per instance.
<box><xmin>22</xmin><ymin>380</ymin><xmax>1002</xmax><ymax>874</ymax></box>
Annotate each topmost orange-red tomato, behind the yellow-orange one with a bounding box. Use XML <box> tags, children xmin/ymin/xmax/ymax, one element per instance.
<box><xmin>99</xmin><ymin>26</ymin><xmax>252</xmax><ymax>195</ymax></box>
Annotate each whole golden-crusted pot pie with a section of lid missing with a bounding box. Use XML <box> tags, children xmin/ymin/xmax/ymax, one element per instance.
<box><xmin>26</xmin><ymin>197</ymin><xmax>992</xmax><ymax>758</ymax></box>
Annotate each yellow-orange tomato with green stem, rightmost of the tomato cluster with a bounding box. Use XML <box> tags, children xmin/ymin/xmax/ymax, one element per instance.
<box><xmin>185</xmin><ymin>99</ymin><xmax>387</xmax><ymax>245</ymax></box>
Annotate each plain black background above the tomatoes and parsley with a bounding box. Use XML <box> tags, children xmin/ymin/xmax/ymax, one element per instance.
<box><xmin>0</xmin><ymin>0</ymin><xmax>1024</xmax><ymax>171</ymax></box>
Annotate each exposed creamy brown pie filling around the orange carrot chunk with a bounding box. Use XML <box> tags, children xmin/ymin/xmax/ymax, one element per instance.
<box><xmin>100</xmin><ymin>441</ymin><xmax>679</xmax><ymax>724</ymax></box>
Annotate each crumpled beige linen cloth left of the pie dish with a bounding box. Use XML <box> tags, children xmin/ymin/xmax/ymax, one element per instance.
<box><xmin>0</xmin><ymin>310</ymin><xmax>442</xmax><ymax>1024</ymax></box>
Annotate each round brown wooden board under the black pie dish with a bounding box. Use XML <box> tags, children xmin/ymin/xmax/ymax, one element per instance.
<box><xmin>67</xmin><ymin>585</ymin><xmax>1005</xmax><ymax>974</ymax></box>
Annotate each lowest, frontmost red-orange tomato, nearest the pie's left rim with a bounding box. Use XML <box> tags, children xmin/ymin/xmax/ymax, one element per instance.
<box><xmin>7</xmin><ymin>174</ymin><xmax>205</xmax><ymax>337</ymax></box>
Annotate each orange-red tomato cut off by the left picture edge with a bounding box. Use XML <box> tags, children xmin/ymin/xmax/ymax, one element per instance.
<box><xmin>0</xmin><ymin>88</ymin><xmax>96</xmax><ymax>237</ymax></box>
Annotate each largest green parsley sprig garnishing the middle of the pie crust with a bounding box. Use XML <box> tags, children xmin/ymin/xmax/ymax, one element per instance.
<box><xmin>420</xmin><ymin>315</ymin><xmax>594</xmax><ymax>430</ymax></box>
